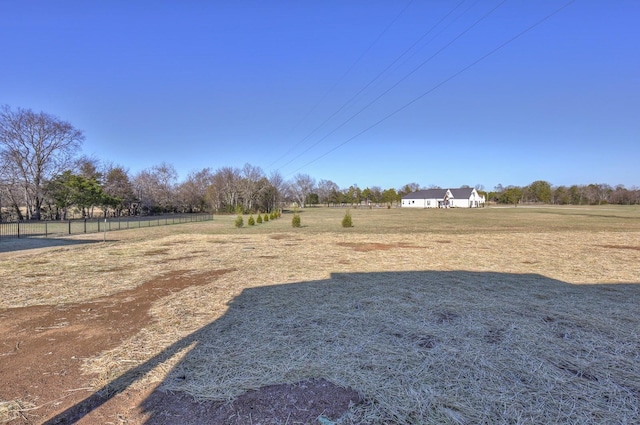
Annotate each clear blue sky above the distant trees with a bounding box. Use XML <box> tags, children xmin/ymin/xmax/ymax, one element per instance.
<box><xmin>0</xmin><ymin>0</ymin><xmax>640</xmax><ymax>189</ymax></box>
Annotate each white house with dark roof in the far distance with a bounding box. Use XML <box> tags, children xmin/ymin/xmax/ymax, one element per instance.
<box><xmin>401</xmin><ymin>187</ymin><xmax>485</xmax><ymax>208</ymax></box>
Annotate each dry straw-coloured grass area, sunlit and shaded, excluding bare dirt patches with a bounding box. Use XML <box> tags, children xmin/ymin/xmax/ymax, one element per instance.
<box><xmin>0</xmin><ymin>206</ymin><xmax>640</xmax><ymax>424</ymax></box>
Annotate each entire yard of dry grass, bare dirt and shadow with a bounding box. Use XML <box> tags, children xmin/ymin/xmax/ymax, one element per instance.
<box><xmin>0</xmin><ymin>206</ymin><xmax>640</xmax><ymax>424</ymax></box>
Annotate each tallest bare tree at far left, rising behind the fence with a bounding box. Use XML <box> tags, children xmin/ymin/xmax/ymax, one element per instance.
<box><xmin>0</xmin><ymin>105</ymin><xmax>84</xmax><ymax>220</ymax></box>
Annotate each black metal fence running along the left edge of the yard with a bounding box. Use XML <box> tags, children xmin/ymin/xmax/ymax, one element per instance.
<box><xmin>0</xmin><ymin>214</ymin><xmax>213</xmax><ymax>238</ymax></box>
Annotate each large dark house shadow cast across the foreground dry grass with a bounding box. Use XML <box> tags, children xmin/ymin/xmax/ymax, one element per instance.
<box><xmin>41</xmin><ymin>271</ymin><xmax>640</xmax><ymax>425</ymax></box>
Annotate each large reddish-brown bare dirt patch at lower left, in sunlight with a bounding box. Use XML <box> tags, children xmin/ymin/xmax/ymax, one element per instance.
<box><xmin>0</xmin><ymin>269</ymin><xmax>233</xmax><ymax>423</ymax></box>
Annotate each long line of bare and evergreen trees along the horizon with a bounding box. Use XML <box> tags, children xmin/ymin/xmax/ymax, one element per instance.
<box><xmin>0</xmin><ymin>105</ymin><xmax>640</xmax><ymax>220</ymax></box>
